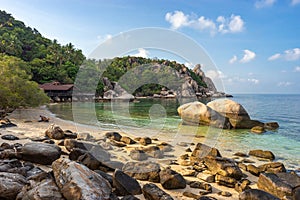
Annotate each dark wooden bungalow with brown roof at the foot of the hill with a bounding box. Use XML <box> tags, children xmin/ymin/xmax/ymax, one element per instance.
<box><xmin>39</xmin><ymin>81</ymin><xmax>74</xmax><ymax>101</ymax></box>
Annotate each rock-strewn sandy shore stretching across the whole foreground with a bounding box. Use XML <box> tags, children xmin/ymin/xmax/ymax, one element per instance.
<box><xmin>0</xmin><ymin>108</ymin><xmax>300</xmax><ymax>200</ymax></box>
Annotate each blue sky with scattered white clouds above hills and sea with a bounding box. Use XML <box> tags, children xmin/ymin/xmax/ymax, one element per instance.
<box><xmin>0</xmin><ymin>0</ymin><xmax>300</xmax><ymax>94</ymax></box>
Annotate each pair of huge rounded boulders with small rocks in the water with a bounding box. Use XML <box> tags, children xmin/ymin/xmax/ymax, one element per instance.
<box><xmin>177</xmin><ymin>99</ymin><xmax>279</xmax><ymax>133</ymax></box>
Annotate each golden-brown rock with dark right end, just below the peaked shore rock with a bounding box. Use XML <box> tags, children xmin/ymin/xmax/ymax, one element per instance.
<box><xmin>204</xmin><ymin>156</ymin><xmax>243</xmax><ymax>180</ymax></box>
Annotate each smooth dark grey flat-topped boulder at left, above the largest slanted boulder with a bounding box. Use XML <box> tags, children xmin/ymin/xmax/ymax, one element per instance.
<box><xmin>20</xmin><ymin>142</ymin><xmax>61</xmax><ymax>165</ymax></box>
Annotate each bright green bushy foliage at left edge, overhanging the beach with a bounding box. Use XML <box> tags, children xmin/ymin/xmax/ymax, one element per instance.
<box><xmin>0</xmin><ymin>54</ymin><xmax>49</xmax><ymax>115</ymax></box>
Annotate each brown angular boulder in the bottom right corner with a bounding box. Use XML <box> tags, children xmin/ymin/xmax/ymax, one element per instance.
<box><xmin>257</xmin><ymin>173</ymin><xmax>300</xmax><ymax>199</ymax></box>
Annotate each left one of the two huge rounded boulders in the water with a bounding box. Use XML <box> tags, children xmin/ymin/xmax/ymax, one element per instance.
<box><xmin>177</xmin><ymin>101</ymin><xmax>231</xmax><ymax>129</ymax></box>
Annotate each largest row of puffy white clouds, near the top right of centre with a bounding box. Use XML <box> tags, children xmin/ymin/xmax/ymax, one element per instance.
<box><xmin>165</xmin><ymin>11</ymin><xmax>244</xmax><ymax>35</ymax></box>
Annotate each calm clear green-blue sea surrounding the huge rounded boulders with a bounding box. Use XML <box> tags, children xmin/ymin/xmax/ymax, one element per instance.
<box><xmin>48</xmin><ymin>94</ymin><xmax>300</xmax><ymax>172</ymax></box>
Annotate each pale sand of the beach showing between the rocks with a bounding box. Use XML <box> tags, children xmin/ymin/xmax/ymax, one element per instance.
<box><xmin>0</xmin><ymin>107</ymin><xmax>282</xmax><ymax>200</ymax></box>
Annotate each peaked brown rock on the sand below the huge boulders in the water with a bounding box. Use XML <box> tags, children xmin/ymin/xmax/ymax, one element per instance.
<box><xmin>191</xmin><ymin>143</ymin><xmax>222</xmax><ymax>160</ymax></box>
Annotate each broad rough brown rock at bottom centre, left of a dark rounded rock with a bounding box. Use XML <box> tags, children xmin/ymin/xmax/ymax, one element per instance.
<box><xmin>122</xmin><ymin>161</ymin><xmax>160</xmax><ymax>183</ymax></box>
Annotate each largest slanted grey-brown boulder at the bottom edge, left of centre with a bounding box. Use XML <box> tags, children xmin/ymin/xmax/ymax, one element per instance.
<box><xmin>52</xmin><ymin>158</ymin><xmax>112</xmax><ymax>200</ymax></box>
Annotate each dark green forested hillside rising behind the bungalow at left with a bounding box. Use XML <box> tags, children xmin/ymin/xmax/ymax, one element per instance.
<box><xmin>0</xmin><ymin>11</ymin><xmax>85</xmax><ymax>83</ymax></box>
